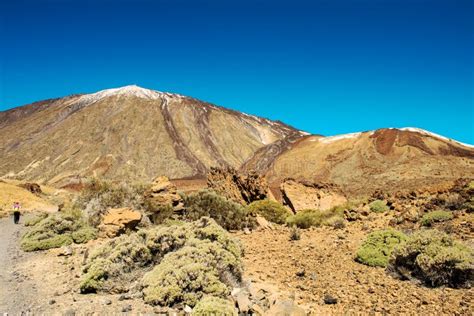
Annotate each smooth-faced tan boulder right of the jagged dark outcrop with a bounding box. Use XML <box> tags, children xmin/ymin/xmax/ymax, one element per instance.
<box><xmin>280</xmin><ymin>179</ymin><xmax>347</xmax><ymax>212</ymax></box>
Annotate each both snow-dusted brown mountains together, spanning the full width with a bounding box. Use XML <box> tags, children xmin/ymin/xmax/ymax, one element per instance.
<box><xmin>0</xmin><ymin>86</ymin><xmax>474</xmax><ymax>193</ymax></box>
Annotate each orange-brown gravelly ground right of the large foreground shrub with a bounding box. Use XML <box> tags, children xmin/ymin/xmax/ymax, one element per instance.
<box><xmin>237</xmin><ymin>220</ymin><xmax>474</xmax><ymax>315</ymax></box>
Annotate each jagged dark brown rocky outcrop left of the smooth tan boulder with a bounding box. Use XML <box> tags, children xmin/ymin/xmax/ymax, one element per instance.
<box><xmin>207</xmin><ymin>167</ymin><xmax>275</xmax><ymax>204</ymax></box>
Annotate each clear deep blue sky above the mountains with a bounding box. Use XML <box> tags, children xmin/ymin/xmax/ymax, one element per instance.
<box><xmin>0</xmin><ymin>0</ymin><xmax>474</xmax><ymax>144</ymax></box>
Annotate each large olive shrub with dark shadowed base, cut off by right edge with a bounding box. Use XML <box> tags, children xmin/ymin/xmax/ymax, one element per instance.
<box><xmin>387</xmin><ymin>230</ymin><xmax>474</xmax><ymax>288</ymax></box>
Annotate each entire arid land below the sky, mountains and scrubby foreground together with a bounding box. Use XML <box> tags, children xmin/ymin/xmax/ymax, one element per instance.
<box><xmin>0</xmin><ymin>86</ymin><xmax>474</xmax><ymax>316</ymax></box>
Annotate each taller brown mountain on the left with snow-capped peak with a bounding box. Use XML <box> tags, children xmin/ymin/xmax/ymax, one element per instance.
<box><xmin>0</xmin><ymin>86</ymin><xmax>304</xmax><ymax>185</ymax></box>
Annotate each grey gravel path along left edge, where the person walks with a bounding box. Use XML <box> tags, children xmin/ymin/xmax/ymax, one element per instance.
<box><xmin>0</xmin><ymin>217</ymin><xmax>37</xmax><ymax>315</ymax></box>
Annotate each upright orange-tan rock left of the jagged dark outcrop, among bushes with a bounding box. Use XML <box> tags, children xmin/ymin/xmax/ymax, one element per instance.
<box><xmin>144</xmin><ymin>176</ymin><xmax>183</xmax><ymax>212</ymax></box>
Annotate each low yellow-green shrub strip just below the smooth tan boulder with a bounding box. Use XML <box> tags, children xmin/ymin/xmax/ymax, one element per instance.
<box><xmin>286</xmin><ymin>208</ymin><xmax>344</xmax><ymax>229</ymax></box>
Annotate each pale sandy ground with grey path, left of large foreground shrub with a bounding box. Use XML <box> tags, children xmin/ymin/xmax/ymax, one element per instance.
<box><xmin>0</xmin><ymin>218</ymin><xmax>157</xmax><ymax>316</ymax></box>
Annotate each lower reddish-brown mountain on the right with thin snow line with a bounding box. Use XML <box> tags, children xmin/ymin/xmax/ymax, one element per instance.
<box><xmin>242</xmin><ymin>128</ymin><xmax>474</xmax><ymax>194</ymax></box>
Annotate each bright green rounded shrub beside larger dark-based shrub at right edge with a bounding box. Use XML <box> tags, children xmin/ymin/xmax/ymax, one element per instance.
<box><xmin>356</xmin><ymin>229</ymin><xmax>407</xmax><ymax>267</ymax></box>
